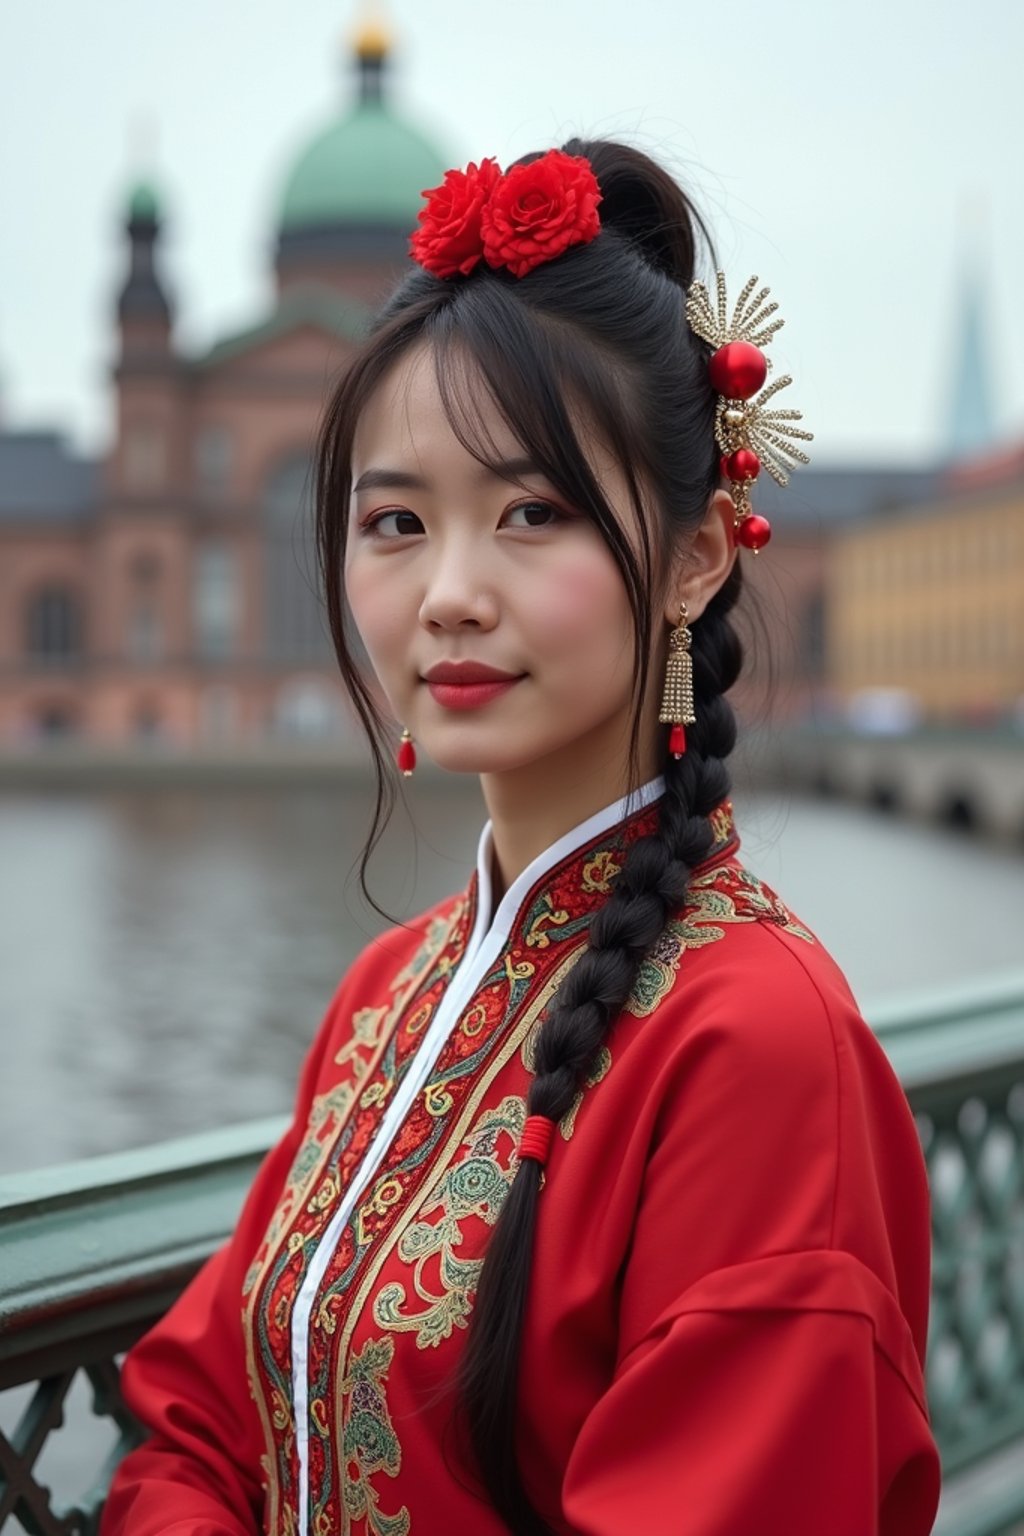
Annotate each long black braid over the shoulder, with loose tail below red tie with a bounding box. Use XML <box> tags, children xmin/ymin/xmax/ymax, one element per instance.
<box><xmin>459</xmin><ymin>562</ymin><xmax>743</xmax><ymax>1536</ymax></box>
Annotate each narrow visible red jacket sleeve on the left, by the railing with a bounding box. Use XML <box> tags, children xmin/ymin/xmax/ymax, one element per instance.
<box><xmin>100</xmin><ymin>972</ymin><xmax>352</xmax><ymax>1536</ymax></box>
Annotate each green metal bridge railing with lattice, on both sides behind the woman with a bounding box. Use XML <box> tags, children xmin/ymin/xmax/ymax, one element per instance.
<box><xmin>0</xmin><ymin>972</ymin><xmax>1024</xmax><ymax>1536</ymax></box>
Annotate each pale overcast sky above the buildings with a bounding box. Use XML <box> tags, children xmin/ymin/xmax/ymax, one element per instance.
<box><xmin>0</xmin><ymin>0</ymin><xmax>1024</xmax><ymax>464</ymax></box>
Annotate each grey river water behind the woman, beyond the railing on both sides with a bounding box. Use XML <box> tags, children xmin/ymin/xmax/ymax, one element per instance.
<box><xmin>0</xmin><ymin>776</ymin><xmax>1024</xmax><ymax>1174</ymax></box>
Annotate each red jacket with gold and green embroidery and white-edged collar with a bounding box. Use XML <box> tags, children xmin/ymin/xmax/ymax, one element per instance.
<box><xmin>101</xmin><ymin>780</ymin><xmax>938</xmax><ymax>1536</ymax></box>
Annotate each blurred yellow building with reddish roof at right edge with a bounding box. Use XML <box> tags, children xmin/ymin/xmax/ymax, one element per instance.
<box><xmin>824</xmin><ymin>447</ymin><xmax>1024</xmax><ymax>722</ymax></box>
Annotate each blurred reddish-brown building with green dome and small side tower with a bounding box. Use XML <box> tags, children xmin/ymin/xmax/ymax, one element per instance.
<box><xmin>0</xmin><ymin>25</ymin><xmax>453</xmax><ymax>748</ymax></box>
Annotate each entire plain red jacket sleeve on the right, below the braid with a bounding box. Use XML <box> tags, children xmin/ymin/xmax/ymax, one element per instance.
<box><xmin>562</xmin><ymin>931</ymin><xmax>940</xmax><ymax>1536</ymax></box>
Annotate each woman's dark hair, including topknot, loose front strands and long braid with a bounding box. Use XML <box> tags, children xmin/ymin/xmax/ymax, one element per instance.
<box><xmin>316</xmin><ymin>138</ymin><xmax>743</xmax><ymax>1536</ymax></box>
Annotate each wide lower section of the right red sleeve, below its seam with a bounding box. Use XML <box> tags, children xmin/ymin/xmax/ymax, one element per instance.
<box><xmin>563</xmin><ymin>1252</ymin><xmax>938</xmax><ymax>1536</ymax></box>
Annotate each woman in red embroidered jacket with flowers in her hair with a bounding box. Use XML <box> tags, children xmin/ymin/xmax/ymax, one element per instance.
<box><xmin>103</xmin><ymin>140</ymin><xmax>938</xmax><ymax>1536</ymax></box>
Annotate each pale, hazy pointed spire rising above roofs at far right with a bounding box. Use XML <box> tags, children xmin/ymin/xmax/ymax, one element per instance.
<box><xmin>946</xmin><ymin>195</ymin><xmax>998</xmax><ymax>462</ymax></box>
